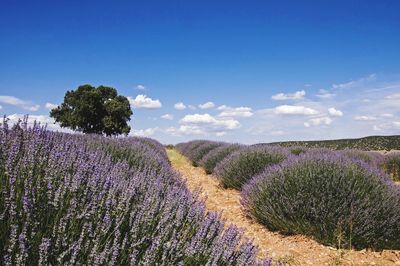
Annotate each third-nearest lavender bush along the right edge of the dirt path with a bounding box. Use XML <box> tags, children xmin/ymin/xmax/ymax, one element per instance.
<box><xmin>199</xmin><ymin>144</ymin><xmax>243</xmax><ymax>174</ymax></box>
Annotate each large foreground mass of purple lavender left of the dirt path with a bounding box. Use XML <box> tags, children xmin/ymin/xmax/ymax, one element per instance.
<box><xmin>0</xmin><ymin>122</ymin><xmax>271</xmax><ymax>265</ymax></box>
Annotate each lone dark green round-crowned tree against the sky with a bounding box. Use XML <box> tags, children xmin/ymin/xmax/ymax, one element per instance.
<box><xmin>50</xmin><ymin>85</ymin><xmax>132</xmax><ymax>136</ymax></box>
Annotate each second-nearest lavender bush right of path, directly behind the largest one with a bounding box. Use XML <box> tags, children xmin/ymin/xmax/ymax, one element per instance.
<box><xmin>215</xmin><ymin>145</ymin><xmax>289</xmax><ymax>190</ymax></box>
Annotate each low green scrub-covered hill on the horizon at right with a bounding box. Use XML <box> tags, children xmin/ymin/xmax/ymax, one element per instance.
<box><xmin>270</xmin><ymin>135</ymin><xmax>400</xmax><ymax>151</ymax></box>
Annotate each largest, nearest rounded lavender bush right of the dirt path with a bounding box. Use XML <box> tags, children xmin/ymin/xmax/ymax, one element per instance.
<box><xmin>242</xmin><ymin>151</ymin><xmax>400</xmax><ymax>249</ymax></box>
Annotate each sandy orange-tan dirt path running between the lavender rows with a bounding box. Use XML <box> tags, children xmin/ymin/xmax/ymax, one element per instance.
<box><xmin>167</xmin><ymin>150</ymin><xmax>400</xmax><ymax>265</ymax></box>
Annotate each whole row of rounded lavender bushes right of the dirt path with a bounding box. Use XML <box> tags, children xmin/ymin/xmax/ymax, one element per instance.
<box><xmin>177</xmin><ymin>141</ymin><xmax>400</xmax><ymax>249</ymax></box>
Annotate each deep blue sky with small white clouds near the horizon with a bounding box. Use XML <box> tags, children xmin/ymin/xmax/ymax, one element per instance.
<box><xmin>0</xmin><ymin>0</ymin><xmax>400</xmax><ymax>143</ymax></box>
